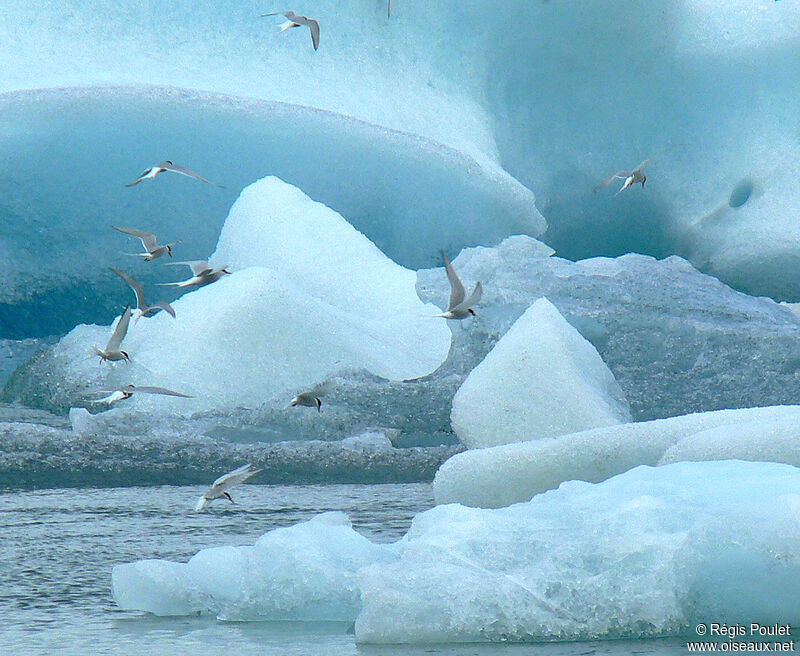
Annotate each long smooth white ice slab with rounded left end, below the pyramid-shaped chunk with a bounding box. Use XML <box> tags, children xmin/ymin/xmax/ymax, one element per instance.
<box><xmin>433</xmin><ymin>406</ymin><xmax>800</xmax><ymax>508</ymax></box>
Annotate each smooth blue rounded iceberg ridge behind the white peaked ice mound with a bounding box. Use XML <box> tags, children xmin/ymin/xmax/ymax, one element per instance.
<box><xmin>0</xmin><ymin>86</ymin><xmax>547</xmax><ymax>338</ymax></box>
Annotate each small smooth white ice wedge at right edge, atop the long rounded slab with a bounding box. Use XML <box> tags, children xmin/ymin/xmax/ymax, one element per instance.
<box><xmin>659</xmin><ymin>415</ymin><xmax>800</xmax><ymax>466</ymax></box>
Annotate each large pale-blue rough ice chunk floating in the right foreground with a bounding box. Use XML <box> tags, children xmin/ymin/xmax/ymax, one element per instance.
<box><xmin>356</xmin><ymin>458</ymin><xmax>800</xmax><ymax>643</ymax></box>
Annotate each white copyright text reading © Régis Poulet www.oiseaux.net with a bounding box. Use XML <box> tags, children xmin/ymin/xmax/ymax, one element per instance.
<box><xmin>686</xmin><ymin>622</ymin><xmax>795</xmax><ymax>653</ymax></box>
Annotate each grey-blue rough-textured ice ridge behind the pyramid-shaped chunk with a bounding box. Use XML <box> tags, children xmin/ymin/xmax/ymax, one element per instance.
<box><xmin>417</xmin><ymin>238</ymin><xmax>800</xmax><ymax>421</ymax></box>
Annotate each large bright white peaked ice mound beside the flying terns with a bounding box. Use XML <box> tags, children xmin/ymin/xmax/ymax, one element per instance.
<box><xmin>6</xmin><ymin>178</ymin><xmax>451</xmax><ymax>414</ymax></box>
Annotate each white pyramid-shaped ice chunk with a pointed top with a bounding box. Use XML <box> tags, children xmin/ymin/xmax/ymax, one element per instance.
<box><xmin>451</xmin><ymin>298</ymin><xmax>631</xmax><ymax>448</ymax></box>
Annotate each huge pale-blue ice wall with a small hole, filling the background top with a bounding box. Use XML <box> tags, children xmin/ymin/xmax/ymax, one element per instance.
<box><xmin>0</xmin><ymin>0</ymin><xmax>800</xmax><ymax>300</ymax></box>
